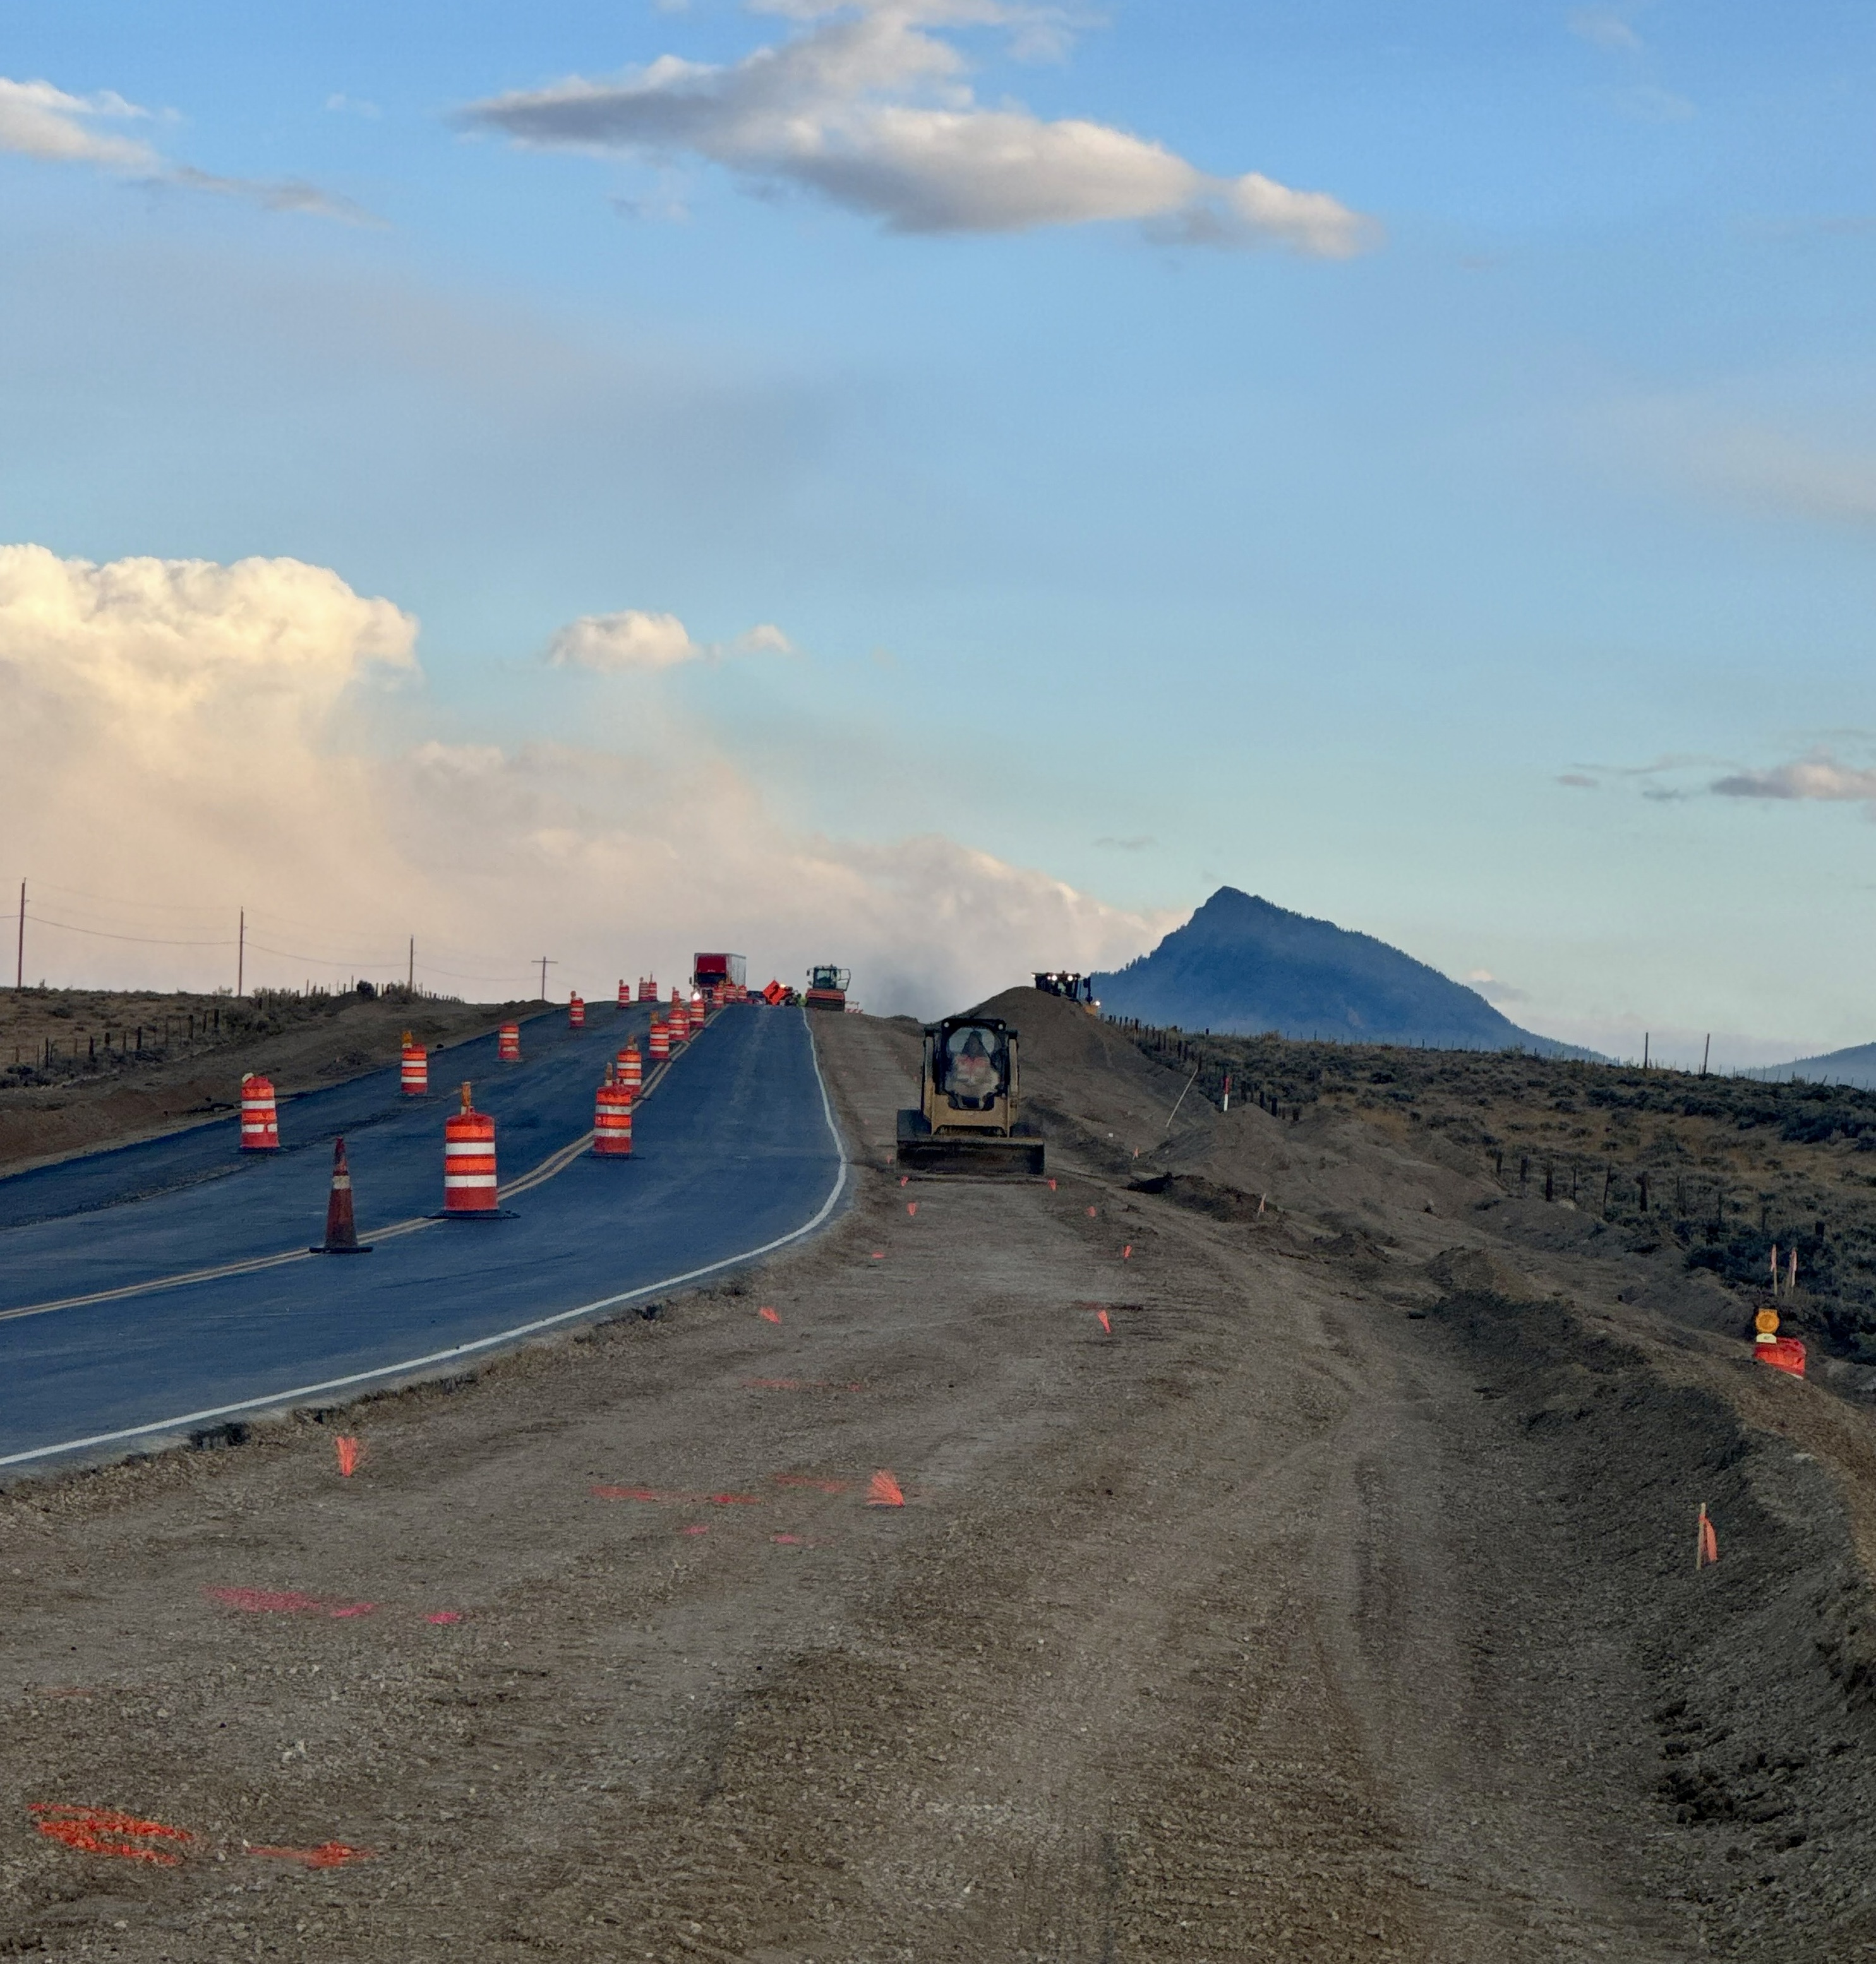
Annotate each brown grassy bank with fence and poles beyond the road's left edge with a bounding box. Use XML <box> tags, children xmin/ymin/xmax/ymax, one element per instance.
<box><xmin>0</xmin><ymin>990</ymin><xmax>540</xmax><ymax>1173</ymax></box>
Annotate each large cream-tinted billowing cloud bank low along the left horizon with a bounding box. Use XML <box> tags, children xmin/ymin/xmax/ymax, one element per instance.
<box><xmin>0</xmin><ymin>546</ymin><xmax>1173</xmax><ymax>1014</ymax></box>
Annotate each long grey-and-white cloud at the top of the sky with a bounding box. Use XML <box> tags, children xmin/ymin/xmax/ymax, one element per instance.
<box><xmin>462</xmin><ymin>0</ymin><xmax>1373</xmax><ymax>257</ymax></box>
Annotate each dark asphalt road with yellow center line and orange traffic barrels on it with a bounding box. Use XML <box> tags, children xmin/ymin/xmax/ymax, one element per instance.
<box><xmin>0</xmin><ymin>1003</ymin><xmax>843</xmax><ymax>1467</ymax></box>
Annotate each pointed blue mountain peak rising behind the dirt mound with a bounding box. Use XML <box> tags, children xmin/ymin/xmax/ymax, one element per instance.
<box><xmin>1094</xmin><ymin>886</ymin><xmax>1591</xmax><ymax>1057</ymax></box>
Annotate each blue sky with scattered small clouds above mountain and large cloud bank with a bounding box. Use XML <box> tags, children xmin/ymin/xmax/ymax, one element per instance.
<box><xmin>0</xmin><ymin>0</ymin><xmax>1876</xmax><ymax>1058</ymax></box>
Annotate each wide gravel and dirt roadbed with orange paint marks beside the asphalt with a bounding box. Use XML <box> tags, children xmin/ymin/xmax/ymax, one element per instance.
<box><xmin>0</xmin><ymin>1003</ymin><xmax>1876</xmax><ymax>1964</ymax></box>
